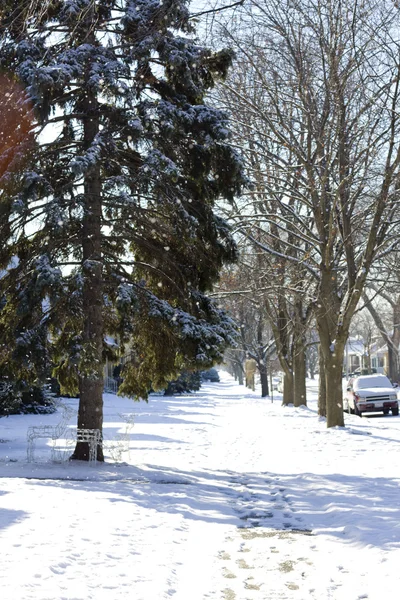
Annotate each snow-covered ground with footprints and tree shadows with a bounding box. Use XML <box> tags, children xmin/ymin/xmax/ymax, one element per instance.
<box><xmin>0</xmin><ymin>373</ymin><xmax>400</xmax><ymax>600</ymax></box>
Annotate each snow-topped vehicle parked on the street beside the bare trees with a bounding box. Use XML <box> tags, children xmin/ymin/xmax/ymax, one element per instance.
<box><xmin>343</xmin><ymin>374</ymin><xmax>399</xmax><ymax>417</ymax></box>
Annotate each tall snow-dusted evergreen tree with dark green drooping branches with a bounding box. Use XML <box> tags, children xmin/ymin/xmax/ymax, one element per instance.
<box><xmin>0</xmin><ymin>0</ymin><xmax>243</xmax><ymax>460</ymax></box>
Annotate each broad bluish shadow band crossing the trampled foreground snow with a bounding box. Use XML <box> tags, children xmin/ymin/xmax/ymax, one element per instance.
<box><xmin>28</xmin><ymin>465</ymin><xmax>400</xmax><ymax>549</ymax></box>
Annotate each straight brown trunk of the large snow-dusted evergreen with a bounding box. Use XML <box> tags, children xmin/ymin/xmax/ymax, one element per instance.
<box><xmin>71</xmin><ymin>77</ymin><xmax>104</xmax><ymax>461</ymax></box>
